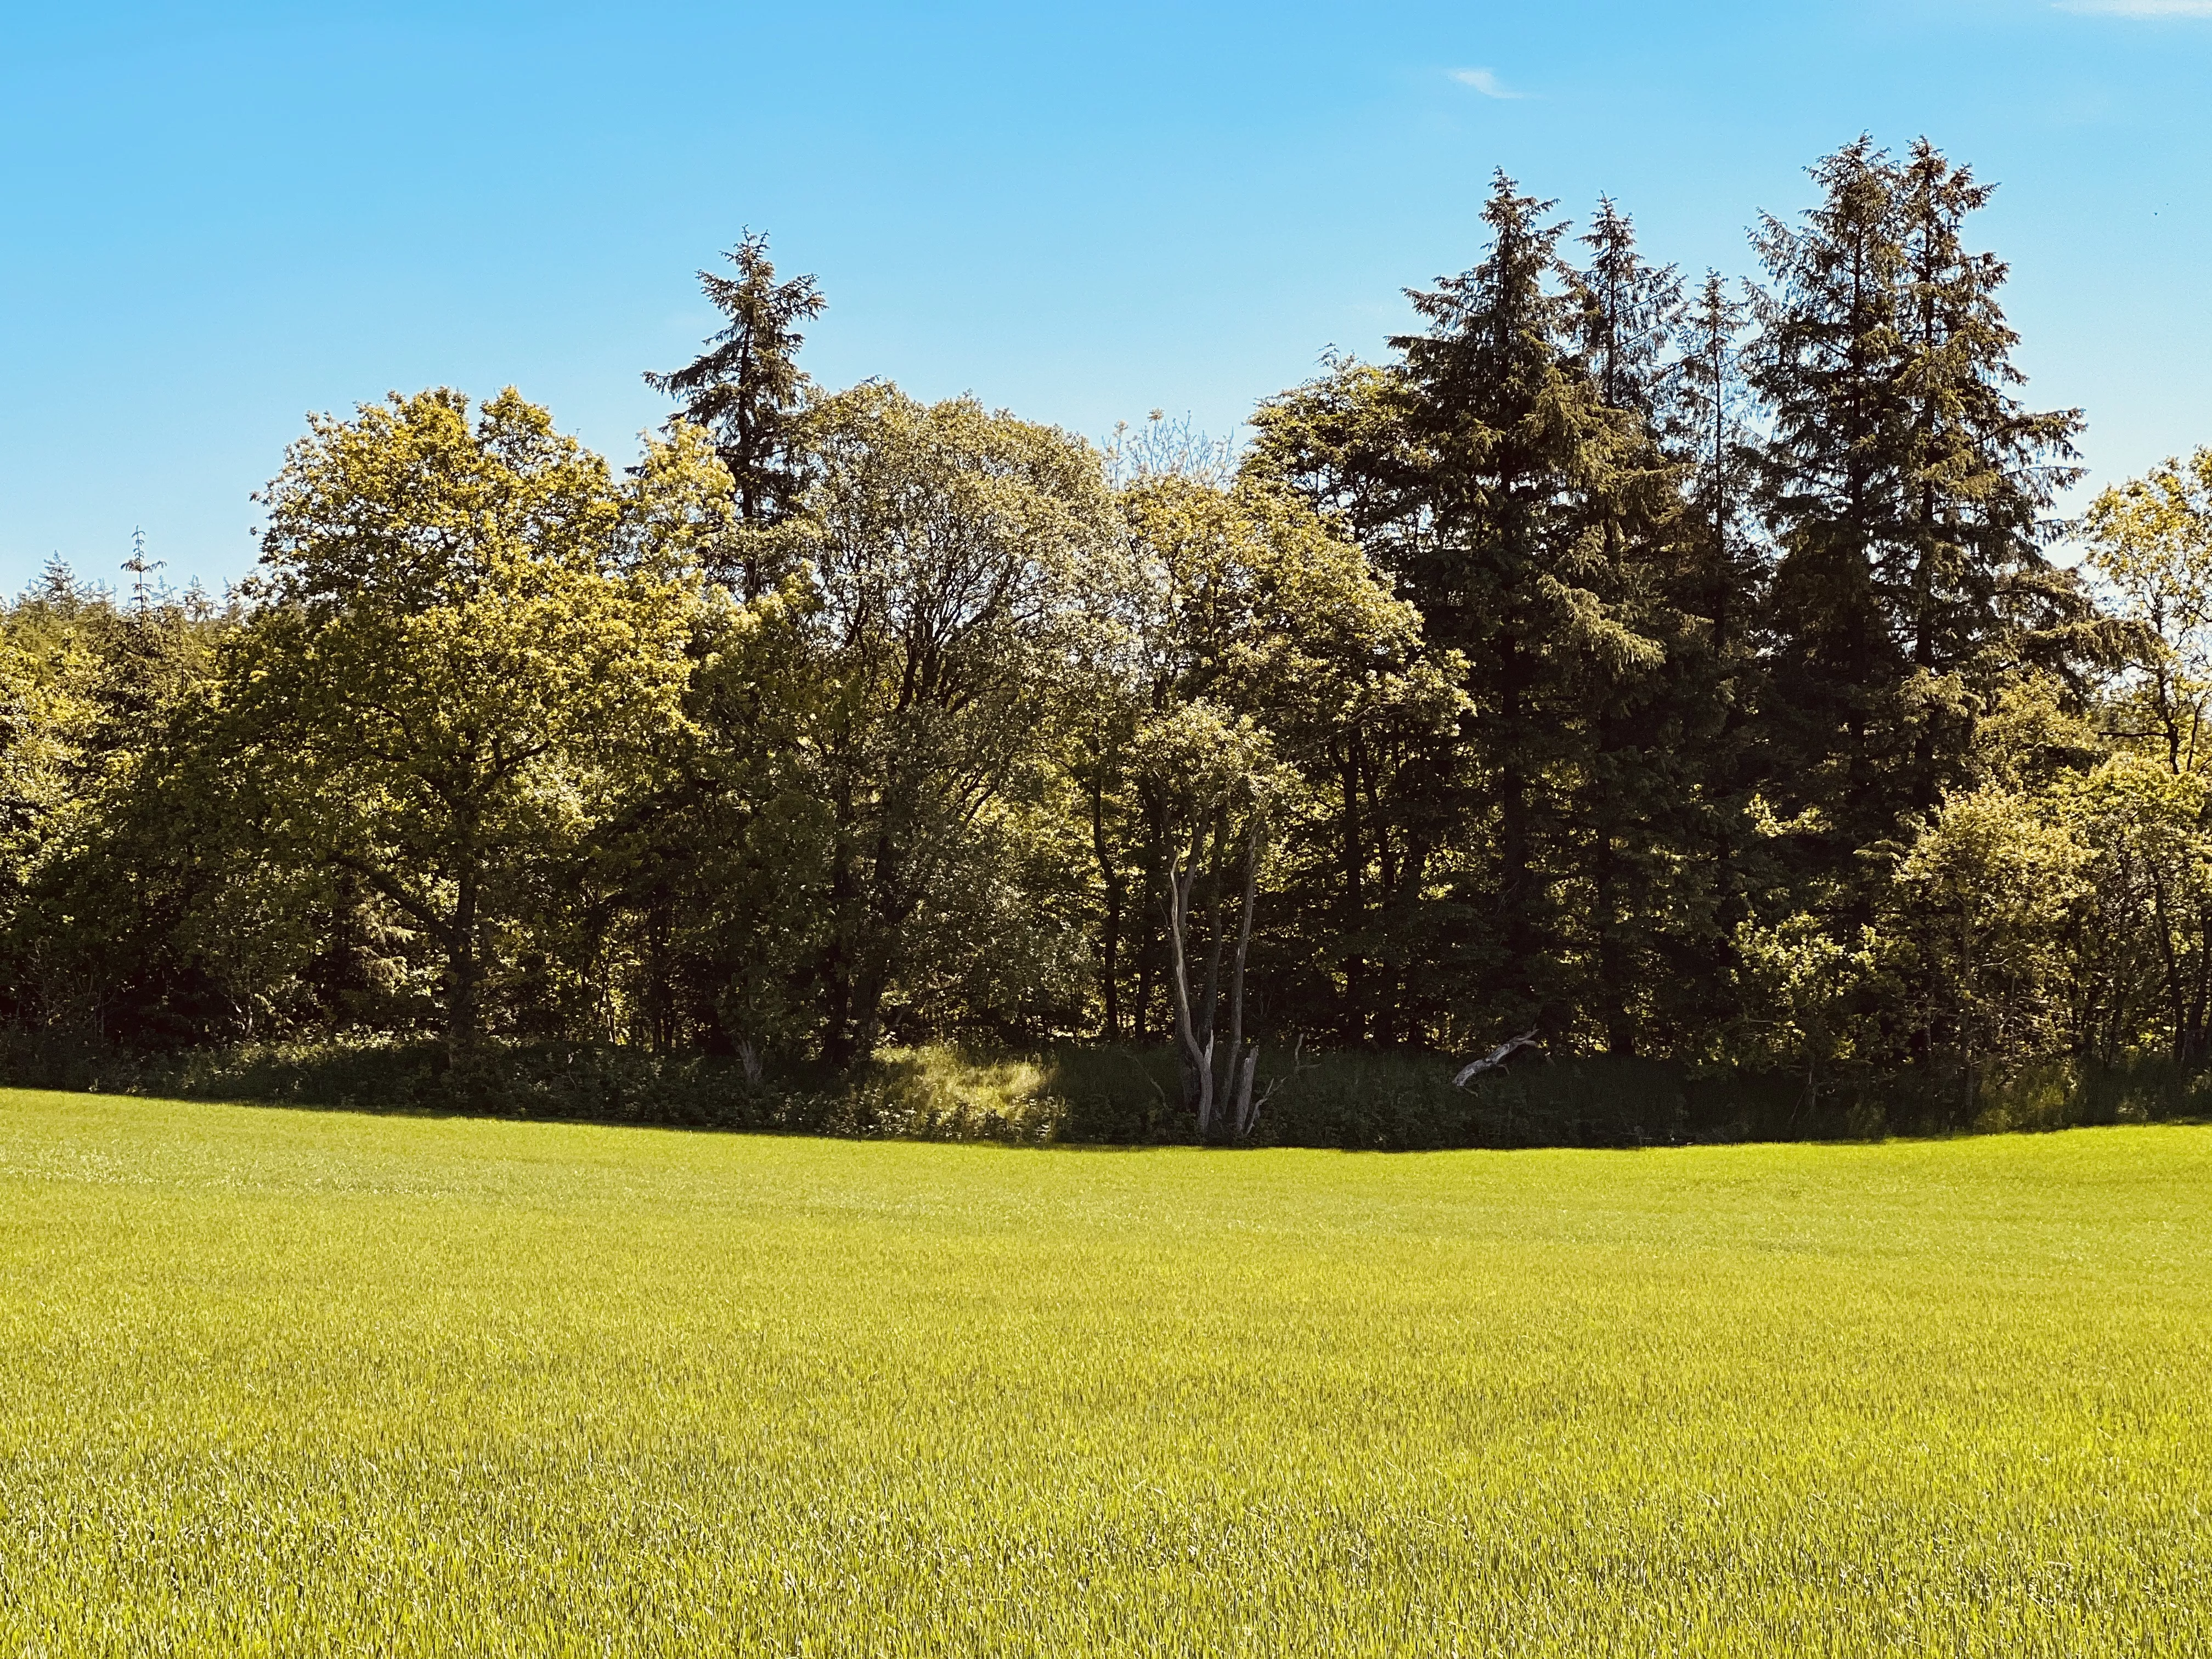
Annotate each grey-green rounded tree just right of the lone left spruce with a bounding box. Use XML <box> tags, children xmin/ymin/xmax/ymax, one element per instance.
<box><xmin>801</xmin><ymin>385</ymin><xmax>1124</xmax><ymax>1059</ymax></box>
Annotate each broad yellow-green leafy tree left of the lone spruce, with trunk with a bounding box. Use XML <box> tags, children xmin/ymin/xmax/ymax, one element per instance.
<box><xmin>228</xmin><ymin>390</ymin><xmax>699</xmax><ymax>1042</ymax></box>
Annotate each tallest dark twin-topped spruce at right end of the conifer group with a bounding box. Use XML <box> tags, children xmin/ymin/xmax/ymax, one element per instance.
<box><xmin>1752</xmin><ymin>137</ymin><xmax>2081</xmax><ymax>913</ymax></box>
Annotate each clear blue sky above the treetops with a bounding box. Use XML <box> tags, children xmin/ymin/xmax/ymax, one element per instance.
<box><xmin>0</xmin><ymin>0</ymin><xmax>2212</xmax><ymax>589</ymax></box>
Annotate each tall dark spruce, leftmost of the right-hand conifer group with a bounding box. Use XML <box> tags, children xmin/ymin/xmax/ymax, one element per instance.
<box><xmin>1391</xmin><ymin>172</ymin><xmax>1663</xmax><ymax>1035</ymax></box>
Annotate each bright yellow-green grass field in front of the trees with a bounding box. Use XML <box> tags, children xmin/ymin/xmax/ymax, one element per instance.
<box><xmin>0</xmin><ymin>1093</ymin><xmax>2212</xmax><ymax>1655</ymax></box>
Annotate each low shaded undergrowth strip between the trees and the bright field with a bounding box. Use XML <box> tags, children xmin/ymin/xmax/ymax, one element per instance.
<box><xmin>0</xmin><ymin>1035</ymin><xmax>2212</xmax><ymax>1153</ymax></box>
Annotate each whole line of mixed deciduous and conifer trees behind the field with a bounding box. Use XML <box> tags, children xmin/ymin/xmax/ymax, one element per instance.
<box><xmin>0</xmin><ymin>139</ymin><xmax>2212</xmax><ymax>1135</ymax></box>
